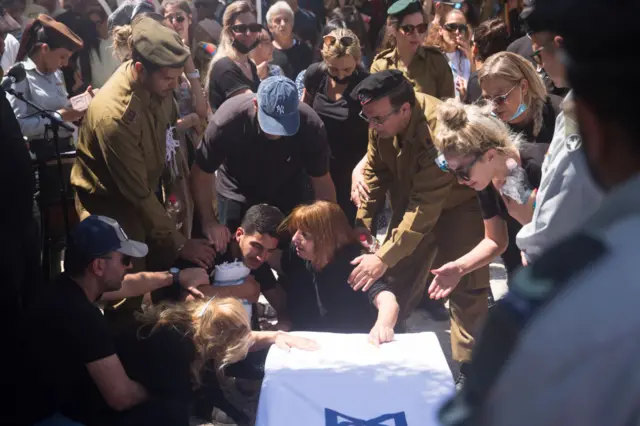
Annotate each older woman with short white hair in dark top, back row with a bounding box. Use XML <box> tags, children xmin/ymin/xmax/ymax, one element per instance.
<box><xmin>267</xmin><ymin>1</ymin><xmax>313</xmax><ymax>81</ymax></box>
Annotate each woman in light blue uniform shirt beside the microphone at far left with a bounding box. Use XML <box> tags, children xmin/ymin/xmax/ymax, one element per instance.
<box><xmin>7</xmin><ymin>15</ymin><xmax>86</xmax><ymax>159</ymax></box>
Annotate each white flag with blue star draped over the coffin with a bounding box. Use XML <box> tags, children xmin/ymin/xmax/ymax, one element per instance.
<box><xmin>256</xmin><ymin>333</ymin><xmax>454</xmax><ymax>426</ymax></box>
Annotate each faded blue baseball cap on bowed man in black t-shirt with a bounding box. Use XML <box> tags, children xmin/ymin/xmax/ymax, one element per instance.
<box><xmin>258</xmin><ymin>76</ymin><xmax>300</xmax><ymax>136</ymax></box>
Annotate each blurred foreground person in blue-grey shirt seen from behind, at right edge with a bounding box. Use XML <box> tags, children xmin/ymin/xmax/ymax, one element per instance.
<box><xmin>440</xmin><ymin>0</ymin><xmax>640</xmax><ymax>426</ymax></box>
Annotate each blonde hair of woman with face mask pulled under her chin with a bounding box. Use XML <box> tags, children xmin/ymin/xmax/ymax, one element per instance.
<box><xmin>478</xmin><ymin>52</ymin><xmax>548</xmax><ymax>136</ymax></box>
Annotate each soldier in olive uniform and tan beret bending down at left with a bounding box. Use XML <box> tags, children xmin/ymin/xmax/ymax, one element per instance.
<box><xmin>71</xmin><ymin>17</ymin><xmax>214</xmax><ymax>316</ymax></box>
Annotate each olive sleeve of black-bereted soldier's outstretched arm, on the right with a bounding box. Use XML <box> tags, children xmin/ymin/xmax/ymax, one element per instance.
<box><xmin>376</xmin><ymin>148</ymin><xmax>454</xmax><ymax>267</ymax></box>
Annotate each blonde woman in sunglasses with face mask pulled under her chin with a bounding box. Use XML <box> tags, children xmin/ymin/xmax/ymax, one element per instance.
<box><xmin>478</xmin><ymin>52</ymin><xmax>557</xmax><ymax>143</ymax></box>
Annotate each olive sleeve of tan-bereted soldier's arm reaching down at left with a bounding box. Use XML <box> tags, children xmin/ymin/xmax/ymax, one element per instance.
<box><xmin>95</xmin><ymin>118</ymin><xmax>185</xmax><ymax>262</ymax></box>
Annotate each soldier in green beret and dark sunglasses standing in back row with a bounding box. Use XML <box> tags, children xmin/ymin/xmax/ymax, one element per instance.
<box><xmin>371</xmin><ymin>0</ymin><xmax>455</xmax><ymax>99</ymax></box>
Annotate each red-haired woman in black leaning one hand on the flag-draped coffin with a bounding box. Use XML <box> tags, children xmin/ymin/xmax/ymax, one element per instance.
<box><xmin>280</xmin><ymin>201</ymin><xmax>399</xmax><ymax>345</ymax></box>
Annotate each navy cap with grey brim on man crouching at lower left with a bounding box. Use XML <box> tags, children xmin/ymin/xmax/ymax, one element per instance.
<box><xmin>67</xmin><ymin>215</ymin><xmax>149</xmax><ymax>259</ymax></box>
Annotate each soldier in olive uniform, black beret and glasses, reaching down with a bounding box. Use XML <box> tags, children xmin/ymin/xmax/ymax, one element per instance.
<box><xmin>351</xmin><ymin>70</ymin><xmax>489</xmax><ymax>382</ymax></box>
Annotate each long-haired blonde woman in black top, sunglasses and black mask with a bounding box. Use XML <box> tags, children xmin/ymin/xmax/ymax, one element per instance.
<box><xmin>206</xmin><ymin>0</ymin><xmax>262</xmax><ymax>111</ymax></box>
